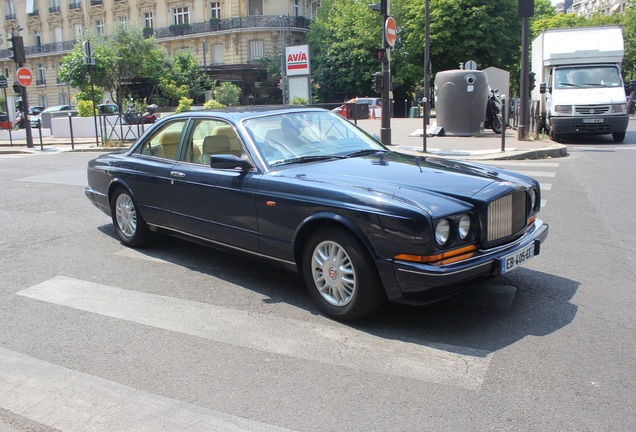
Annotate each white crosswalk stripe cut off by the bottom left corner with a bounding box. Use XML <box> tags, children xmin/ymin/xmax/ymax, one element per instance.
<box><xmin>0</xmin><ymin>348</ymin><xmax>296</xmax><ymax>432</ymax></box>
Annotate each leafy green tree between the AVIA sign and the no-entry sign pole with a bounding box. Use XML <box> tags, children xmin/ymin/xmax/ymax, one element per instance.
<box><xmin>308</xmin><ymin>0</ymin><xmax>382</xmax><ymax>101</ymax></box>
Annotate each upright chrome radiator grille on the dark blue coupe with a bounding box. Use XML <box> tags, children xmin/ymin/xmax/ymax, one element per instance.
<box><xmin>487</xmin><ymin>191</ymin><xmax>527</xmax><ymax>242</ymax></box>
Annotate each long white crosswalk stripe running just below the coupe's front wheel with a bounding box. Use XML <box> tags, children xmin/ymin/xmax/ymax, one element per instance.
<box><xmin>17</xmin><ymin>276</ymin><xmax>492</xmax><ymax>390</ymax></box>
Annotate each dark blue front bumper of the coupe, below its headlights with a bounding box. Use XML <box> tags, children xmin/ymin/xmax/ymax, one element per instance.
<box><xmin>391</xmin><ymin>219</ymin><xmax>548</xmax><ymax>304</ymax></box>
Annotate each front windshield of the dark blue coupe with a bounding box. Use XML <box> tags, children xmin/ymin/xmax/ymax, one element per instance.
<box><xmin>243</xmin><ymin>111</ymin><xmax>386</xmax><ymax>167</ymax></box>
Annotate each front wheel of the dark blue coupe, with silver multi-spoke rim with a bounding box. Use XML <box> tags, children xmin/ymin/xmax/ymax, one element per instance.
<box><xmin>302</xmin><ymin>227</ymin><xmax>386</xmax><ymax>321</ymax></box>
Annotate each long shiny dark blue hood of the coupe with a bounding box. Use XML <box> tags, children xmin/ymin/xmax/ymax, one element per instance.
<box><xmin>272</xmin><ymin>152</ymin><xmax>538</xmax><ymax>215</ymax></box>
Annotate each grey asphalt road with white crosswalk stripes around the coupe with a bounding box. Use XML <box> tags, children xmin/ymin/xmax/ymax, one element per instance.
<box><xmin>0</xmin><ymin>131</ymin><xmax>636</xmax><ymax>432</ymax></box>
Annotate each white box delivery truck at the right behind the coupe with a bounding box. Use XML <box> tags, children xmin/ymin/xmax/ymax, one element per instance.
<box><xmin>532</xmin><ymin>26</ymin><xmax>629</xmax><ymax>142</ymax></box>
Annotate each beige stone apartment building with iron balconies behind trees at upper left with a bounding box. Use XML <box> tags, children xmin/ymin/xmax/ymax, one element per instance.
<box><xmin>0</xmin><ymin>0</ymin><xmax>319</xmax><ymax>106</ymax></box>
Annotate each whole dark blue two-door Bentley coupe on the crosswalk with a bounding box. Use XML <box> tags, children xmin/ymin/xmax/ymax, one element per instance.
<box><xmin>86</xmin><ymin>107</ymin><xmax>548</xmax><ymax>320</ymax></box>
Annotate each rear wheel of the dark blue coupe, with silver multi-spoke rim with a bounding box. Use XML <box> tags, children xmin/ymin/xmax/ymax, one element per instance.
<box><xmin>110</xmin><ymin>188</ymin><xmax>150</xmax><ymax>247</ymax></box>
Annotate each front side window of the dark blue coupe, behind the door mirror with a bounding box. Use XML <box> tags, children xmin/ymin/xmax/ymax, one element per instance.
<box><xmin>184</xmin><ymin>119</ymin><xmax>245</xmax><ymax>165</ymax></box>
